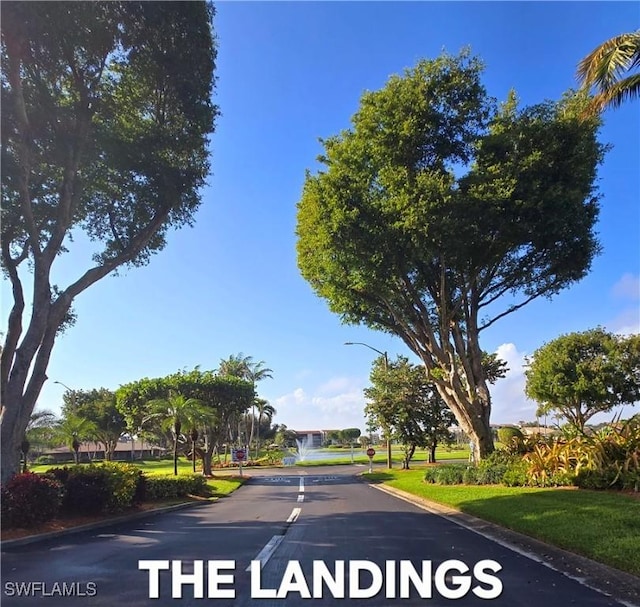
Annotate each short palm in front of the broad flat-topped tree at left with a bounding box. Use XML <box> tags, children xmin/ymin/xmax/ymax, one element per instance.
<box><xmin>147</xmin><ymin>392</ymin><xmax>209</xmax><ymax>476</ymax></box>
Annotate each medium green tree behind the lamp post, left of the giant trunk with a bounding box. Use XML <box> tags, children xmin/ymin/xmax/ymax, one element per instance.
<box><xmin>364</xmin><ymin>356</ymin><xmax>457</xmax><ymax>469</ymax></box>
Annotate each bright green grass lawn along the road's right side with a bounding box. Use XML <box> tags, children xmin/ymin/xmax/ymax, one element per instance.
<box><xmin>363</xmin><ymin>469</ymin><xmax>640</xmax><ymax>575</ymax></box>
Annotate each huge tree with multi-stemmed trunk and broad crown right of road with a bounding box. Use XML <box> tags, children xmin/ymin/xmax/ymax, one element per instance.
<box><xmin>297</xmin><ymin>52</ymin><xmax>603</xmax><ymax>458</ymax></box>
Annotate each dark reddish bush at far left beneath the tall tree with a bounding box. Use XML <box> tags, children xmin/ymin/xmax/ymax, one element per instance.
<box><xmin>1</xmin><ymin>472</ymin><xmax>64</xmax><ymax>527</ymax></box>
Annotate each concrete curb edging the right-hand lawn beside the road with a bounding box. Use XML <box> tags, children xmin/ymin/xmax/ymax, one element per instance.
<box><xmin>361</xmin><ymin>476</ymin><xmax>640</xmax><ymax>607</ymax></box>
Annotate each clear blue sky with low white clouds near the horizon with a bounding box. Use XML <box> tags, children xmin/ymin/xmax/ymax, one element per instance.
<box><xmin>2</xmin><ymin>2</ymin><xmax>640</xmax><ymax>431</ymax></box>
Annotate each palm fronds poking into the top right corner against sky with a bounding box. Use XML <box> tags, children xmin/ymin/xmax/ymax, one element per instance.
<box><xmin>578</xmin><ymin>30</ymin><xmax>640</xmax><ymax>112</ymax></box>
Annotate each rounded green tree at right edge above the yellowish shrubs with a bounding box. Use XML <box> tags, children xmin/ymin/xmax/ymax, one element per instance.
<box><xmin>525</xmin><ymin>327</ymin><xmax>640</xmax><ymax>432</ymax></box>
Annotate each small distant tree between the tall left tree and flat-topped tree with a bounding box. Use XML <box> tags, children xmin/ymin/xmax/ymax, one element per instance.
<box><xmin>62</xmin><ymin>388</ymin><xmax>127</xmax><ymax>461</ymax></box>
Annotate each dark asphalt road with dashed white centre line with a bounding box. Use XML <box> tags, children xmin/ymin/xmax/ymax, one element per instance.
<box><xmin>2</xmin><ymin>467</ymin><xmax>636</xmax><ymax>607</ymax></box>
